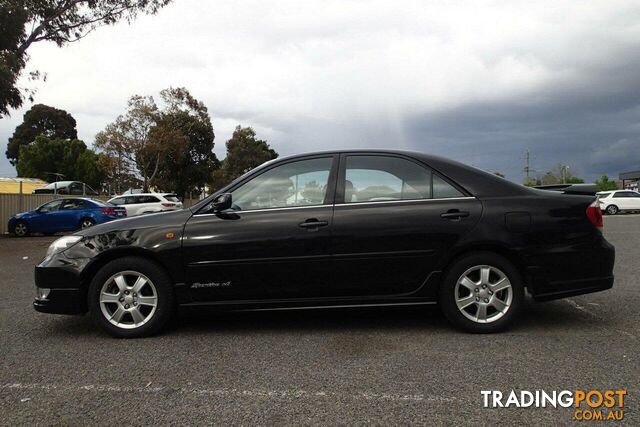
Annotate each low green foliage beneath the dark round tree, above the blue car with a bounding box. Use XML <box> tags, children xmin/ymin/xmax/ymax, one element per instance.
<box><xmin>16</xmin><ymin>136</ymin><xmax>105</xmax><ymax>189</ymax></box>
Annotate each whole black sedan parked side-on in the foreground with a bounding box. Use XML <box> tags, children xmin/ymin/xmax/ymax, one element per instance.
<box><xmin>34</xmin><ymin>151</ymin><xmax>614</xmax><ymax>337</ymax></box>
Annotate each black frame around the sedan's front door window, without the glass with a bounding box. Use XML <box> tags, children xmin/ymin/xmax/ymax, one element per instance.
<box><xmin>194</xmin><ymin>153</ymin><xmax>339</xmax><ymax>216</ymax></box>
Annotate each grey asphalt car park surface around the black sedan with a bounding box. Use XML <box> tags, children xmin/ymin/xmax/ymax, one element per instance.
<box><xmin>0</xmin><ymin>215</ymin><xmax>640</xmax><ymax>425</ymax></box>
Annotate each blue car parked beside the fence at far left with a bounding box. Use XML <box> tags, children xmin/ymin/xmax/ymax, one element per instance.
<box><xmin>9</xmin><ymin>198</ymin><xmax>127</xmax><ymax>237</ymax></box>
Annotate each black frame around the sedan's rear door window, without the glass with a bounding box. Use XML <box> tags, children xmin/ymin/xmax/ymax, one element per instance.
<box><xmin>334</xmin><ymin>152</ymin><xmax>475</xmax><ymax>206</ymax></box>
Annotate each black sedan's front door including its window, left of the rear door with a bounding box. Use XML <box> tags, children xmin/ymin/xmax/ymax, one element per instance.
<box><xmin>183</xmin><ymin>155</ymin><xmax>337</xmax><ymax>301</ymax></box>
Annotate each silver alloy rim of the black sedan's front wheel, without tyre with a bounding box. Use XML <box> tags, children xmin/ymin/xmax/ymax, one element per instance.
<box><xmin>100</xmin><ymin>271</ymin><xmax>158</xmax><ymax>329</ymax></box>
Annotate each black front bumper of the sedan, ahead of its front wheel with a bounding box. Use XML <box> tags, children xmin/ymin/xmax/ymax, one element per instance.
<box><xmin>33</xmin><ymin>253</ymin><xmax>87</xmax><ymax>314</ymax></box>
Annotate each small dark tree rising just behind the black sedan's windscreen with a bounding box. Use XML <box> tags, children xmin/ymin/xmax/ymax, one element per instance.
<box><xmin>212</xmin><ymin>125</ymin><xmax>278</xmax><ymax>188</ymax></box>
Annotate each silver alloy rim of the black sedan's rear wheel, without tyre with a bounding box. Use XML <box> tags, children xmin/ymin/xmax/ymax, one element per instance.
<box><xmin>454</xmin><ymin>265</ymin><xmax>513</xmax><ymax>323</ymax></box>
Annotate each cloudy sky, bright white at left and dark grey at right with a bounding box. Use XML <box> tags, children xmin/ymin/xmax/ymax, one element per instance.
<box><xmin>0</xmin><ymin>0</ymin><xmax>640</xmax><ymax>181</ymax></box>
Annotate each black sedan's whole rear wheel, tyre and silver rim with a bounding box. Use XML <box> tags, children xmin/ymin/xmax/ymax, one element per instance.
<box><xmin>438</xmin><ymin>252</ymin><xmax>524</xmax><ymax>333</ymax></box>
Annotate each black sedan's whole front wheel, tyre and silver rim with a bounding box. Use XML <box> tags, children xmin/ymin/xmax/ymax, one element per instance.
<box><xmin>87</xmin><ymin>257</ymin><xmax>174</xmax><ymax>338</ymax></box>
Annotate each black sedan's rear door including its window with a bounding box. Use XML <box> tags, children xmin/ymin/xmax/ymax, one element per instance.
<box><xmin>331</xmin><ymin>154</ymin><xmax>482</xmax><ymax>296</ymax></box>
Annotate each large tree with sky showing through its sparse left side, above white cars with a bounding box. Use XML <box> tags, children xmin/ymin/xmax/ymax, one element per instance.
<box><xmin>96</xmin><ymin>88</ymin><xmax>218</xmax><ymax>197</ymax></box>
